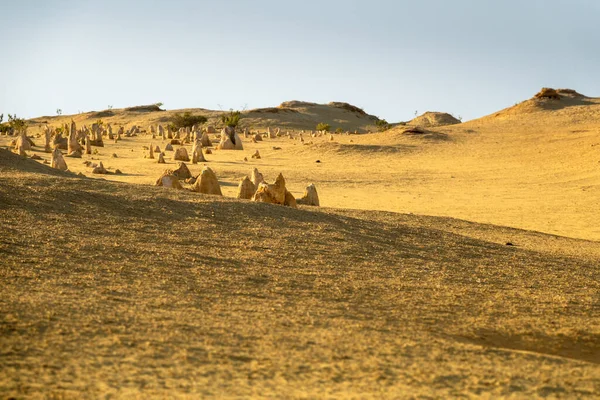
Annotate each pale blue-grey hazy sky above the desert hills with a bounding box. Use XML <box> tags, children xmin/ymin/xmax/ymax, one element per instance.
<box><xmin>0</xmin><ymin>0</ymin><xmax>600</xmax><ymax>122</ymax></box>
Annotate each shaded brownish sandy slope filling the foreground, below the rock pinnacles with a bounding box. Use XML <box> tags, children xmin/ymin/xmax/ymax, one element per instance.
<box><xmin>0</xmin><ymin>151</ymin><xmax>600</xmax><ymax>398</ymax></box>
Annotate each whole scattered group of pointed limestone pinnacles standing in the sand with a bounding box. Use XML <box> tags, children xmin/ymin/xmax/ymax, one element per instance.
<box><xmin>14</xmin><ymin>121</ymin><xmax>322</xmax><ymax>208</ymax></box>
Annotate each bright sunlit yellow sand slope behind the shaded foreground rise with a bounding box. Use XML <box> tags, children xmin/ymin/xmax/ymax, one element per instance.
<box><xmin>4</xmin><ymin>92</ymin><xmax>600</xmax><ymax>240</ymax></box>
